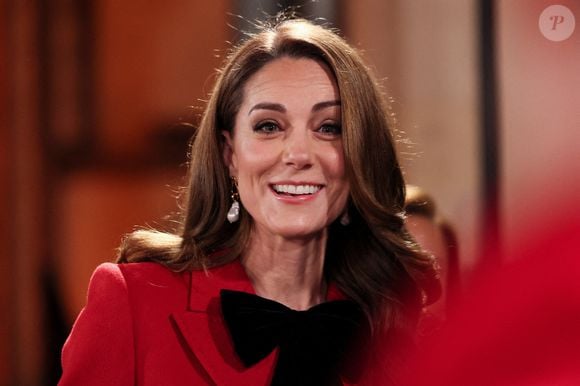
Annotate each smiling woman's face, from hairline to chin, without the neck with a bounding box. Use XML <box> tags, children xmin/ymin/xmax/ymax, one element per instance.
<box><xmin>224</xmin><ymin>58</ymin><xmax>349</xmax><ymax>238</ymax></box>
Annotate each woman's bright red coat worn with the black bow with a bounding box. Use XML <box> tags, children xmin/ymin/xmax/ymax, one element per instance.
<box><xmin>59</xmin><ymin>261</ymin><xmax>356</xmax><ymax>386</ymax></box>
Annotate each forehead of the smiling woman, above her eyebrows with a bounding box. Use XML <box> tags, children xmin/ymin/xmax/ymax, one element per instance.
<box><xmin>242</xmin><ymin>57</ymin><xmax>340</xmax><ymax>105</ymax></box>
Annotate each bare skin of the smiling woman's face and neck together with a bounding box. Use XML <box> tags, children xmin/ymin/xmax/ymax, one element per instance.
<box><xmin>223</xmin><ymin>58</ymin><xmax>349</xmax><ymax>309</ymax></box>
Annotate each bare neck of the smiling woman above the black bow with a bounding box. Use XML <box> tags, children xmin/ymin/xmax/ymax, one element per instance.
<box><xmin>242</xmin><ymin>232</ymin><xmax>326</xmax><ymax>310</ymax></box>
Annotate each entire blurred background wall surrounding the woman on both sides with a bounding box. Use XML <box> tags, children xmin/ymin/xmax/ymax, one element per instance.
<box><xmin>0</xmin><ymin>0</ymin><xmax>580</xmax><ymax>385</ymax></box>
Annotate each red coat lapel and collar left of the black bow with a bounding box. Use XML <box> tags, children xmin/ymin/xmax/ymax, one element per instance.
<box><xmin>172</xmin><ymin>260</ymin><xmax>277</xmax><ymax>385</ymax></box>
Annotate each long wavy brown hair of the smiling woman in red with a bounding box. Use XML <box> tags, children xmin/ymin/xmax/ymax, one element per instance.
<box><xmin>118</xmin><ymin>19</ymin><xmax>440</xmax><ymax>328</ymax></box>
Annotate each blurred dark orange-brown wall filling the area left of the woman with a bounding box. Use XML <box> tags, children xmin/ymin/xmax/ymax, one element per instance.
<box><xmin>5</xmin><ymin>0</ymin><xmax>232</xmax><ymax>385</ymax></box>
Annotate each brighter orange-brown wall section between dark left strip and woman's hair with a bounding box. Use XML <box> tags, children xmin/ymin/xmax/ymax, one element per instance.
<box><xmin>56</xmin><ymin>0</ymin><xmax>229</xmax><ymax>323</ymax></box>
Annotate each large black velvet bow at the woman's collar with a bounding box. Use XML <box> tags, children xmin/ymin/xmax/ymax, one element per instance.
<box><xmin>220</xmin><ymin>290</ymin><xmax>368</xmax><ymax>386</ymax></box>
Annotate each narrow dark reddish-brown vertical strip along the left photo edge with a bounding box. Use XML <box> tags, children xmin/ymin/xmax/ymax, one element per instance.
<box><xmin>0</xmin><ymin>1</ymin><xmax>43</xmax><ymax>385</ymax></box>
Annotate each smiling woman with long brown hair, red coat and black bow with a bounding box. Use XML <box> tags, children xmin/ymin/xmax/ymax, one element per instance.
<box><xmin>61</xmin><ymin>20</ymin><xmax>438</xmax><ymax>385</ymax></box>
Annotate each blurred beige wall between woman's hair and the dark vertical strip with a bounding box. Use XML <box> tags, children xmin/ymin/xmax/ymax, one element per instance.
<box><xmin>346</xmin><ymin>0</ymin><xmax>481</xmax><ymax>270</ymax></box>
